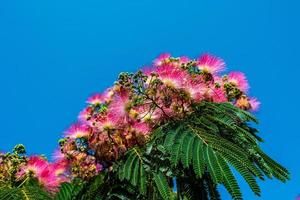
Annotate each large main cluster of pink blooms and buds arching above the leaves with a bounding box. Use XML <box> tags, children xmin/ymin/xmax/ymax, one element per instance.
<box><xmin>59</xmin><ymin>54</ymin><xmax>259</xmax><ymax>179</ymax></box>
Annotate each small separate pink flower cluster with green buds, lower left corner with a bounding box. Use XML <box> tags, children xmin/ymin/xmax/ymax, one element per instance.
<box><xmin>0</xmin><ymin>145</ymin><xmax>69</xmax><ymax>193</ymax></box>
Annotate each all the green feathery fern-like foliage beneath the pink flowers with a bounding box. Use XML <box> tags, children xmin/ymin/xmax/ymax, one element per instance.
<box><xmin>25</xmin><ymin>102</ymin><xmax>289</xmax><ymax>200</ymax></box>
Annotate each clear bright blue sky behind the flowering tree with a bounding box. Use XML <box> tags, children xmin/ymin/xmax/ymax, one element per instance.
<box><xmin>0</xmin><ymin>0</ymin><xmax>300</xmax><ymax>200</ymax></box>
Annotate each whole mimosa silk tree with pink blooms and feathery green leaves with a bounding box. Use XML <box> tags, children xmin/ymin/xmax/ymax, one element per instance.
<box><xmin>0</xmin><ymin>54</ymin><xmax>289</xmax><ymax>200</ymax></box>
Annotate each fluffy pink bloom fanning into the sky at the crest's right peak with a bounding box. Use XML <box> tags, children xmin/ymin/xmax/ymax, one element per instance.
<box><xmin>197</xmin><ymin>54</ymin><xmax>225</xmax><ymax>74</ymax></box>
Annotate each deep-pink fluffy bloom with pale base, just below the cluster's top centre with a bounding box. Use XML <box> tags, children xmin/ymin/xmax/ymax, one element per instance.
<box><xmin>155</xmin><ymin>65</ymin><xmax>188</xmax><ymax>89</ymax></box>
